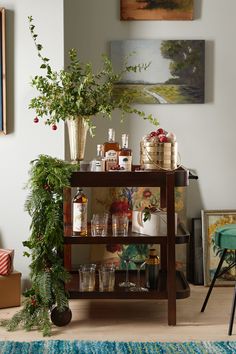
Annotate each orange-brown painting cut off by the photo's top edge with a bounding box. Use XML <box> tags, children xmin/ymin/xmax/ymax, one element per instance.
<box><xmin>120</xmin><ymin>0</ymin><xmax>193</xmax><ymax>21</ymax></box>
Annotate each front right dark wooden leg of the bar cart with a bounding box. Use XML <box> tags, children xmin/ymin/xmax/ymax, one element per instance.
<box><xmin>166</xmin><ymin>171</ymin><xmax>176</xmax><ymax>326</ymax></box>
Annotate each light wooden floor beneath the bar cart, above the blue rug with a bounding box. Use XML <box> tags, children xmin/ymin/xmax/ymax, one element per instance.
<box><xmin>0</xmin><ymin>286</ymin><xmax>236</xmax><ymax>342</ymax></box>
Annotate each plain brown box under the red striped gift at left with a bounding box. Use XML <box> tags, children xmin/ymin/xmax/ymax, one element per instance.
<box><xmin>0</xmin><ymin>271</ymin><xmax>21</xmax><ymax>308</ymax></box>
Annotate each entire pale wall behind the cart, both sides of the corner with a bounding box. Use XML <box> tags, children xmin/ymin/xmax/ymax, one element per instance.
<box><xmin>0</xmin><ymin>0</ymin><xmax>236</xmax><ymax>286</ymax></box>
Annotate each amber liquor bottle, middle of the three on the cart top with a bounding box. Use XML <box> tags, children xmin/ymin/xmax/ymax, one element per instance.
<box><xmin>103</xmin><ymin>128</ymin><xmax>120</xmax><ymax>171</ymax></box>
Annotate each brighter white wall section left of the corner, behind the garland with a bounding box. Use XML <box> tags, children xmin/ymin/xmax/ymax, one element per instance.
<box><xmin>0</xmin><ymin>0</ymin><xmax>64</xmax><ymax>286</ymax></box>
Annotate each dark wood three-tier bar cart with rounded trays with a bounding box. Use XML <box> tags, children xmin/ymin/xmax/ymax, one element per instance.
<box><xmin>64</xmin><ymin>167</ymin><xmax>190</xmax><ymax>325</ymax></box>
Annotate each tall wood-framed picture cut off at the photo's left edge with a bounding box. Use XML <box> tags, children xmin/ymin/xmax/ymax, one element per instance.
<box><xmin>0</xmin><ymin>8</ymin><xmax>7</xmax><ymax>134</ymax></box>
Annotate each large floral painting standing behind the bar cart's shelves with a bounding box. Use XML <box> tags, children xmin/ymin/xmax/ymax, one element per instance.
<box><xmin>90</xmin><ymin>187</ymin><xmax>187</xmax><ymax>271</ymax></box>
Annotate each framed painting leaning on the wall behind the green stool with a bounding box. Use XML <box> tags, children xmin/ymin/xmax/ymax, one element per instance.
<box><xmin>201</xmin><ymin>210</ymin><xmax>236</xmax><ymax>286</ymax></box>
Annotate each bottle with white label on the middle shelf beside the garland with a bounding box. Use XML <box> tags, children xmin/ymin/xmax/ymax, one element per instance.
<box><xmin>73</xmin><ymin>187</ymin><xmax>88</xmax><ymax>236</ymax></box>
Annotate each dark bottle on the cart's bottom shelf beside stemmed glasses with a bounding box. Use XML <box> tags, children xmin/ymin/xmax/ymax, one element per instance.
<box><xmin>146</xmin><ymin>248</ymin><xmax>160</xmax><ymax>290</ymax></box>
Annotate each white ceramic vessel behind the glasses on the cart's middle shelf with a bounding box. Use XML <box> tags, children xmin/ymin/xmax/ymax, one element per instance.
<box><xmin>132</xmin><ymin>210</ymin><xmax>177</xmax><ymax>236</ymax></box>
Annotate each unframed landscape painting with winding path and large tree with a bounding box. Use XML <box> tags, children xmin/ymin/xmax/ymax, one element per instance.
<box><xmin>110</xmin><ymin>39</ymin><xmax>205</xmax><ymax>104</ymax></box>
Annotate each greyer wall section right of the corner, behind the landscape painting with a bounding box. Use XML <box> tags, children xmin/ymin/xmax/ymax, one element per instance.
<box><xmin>65</xmin><ymin>0</ymin><xmax>236</xmax><ymax>221</ymax></box>
